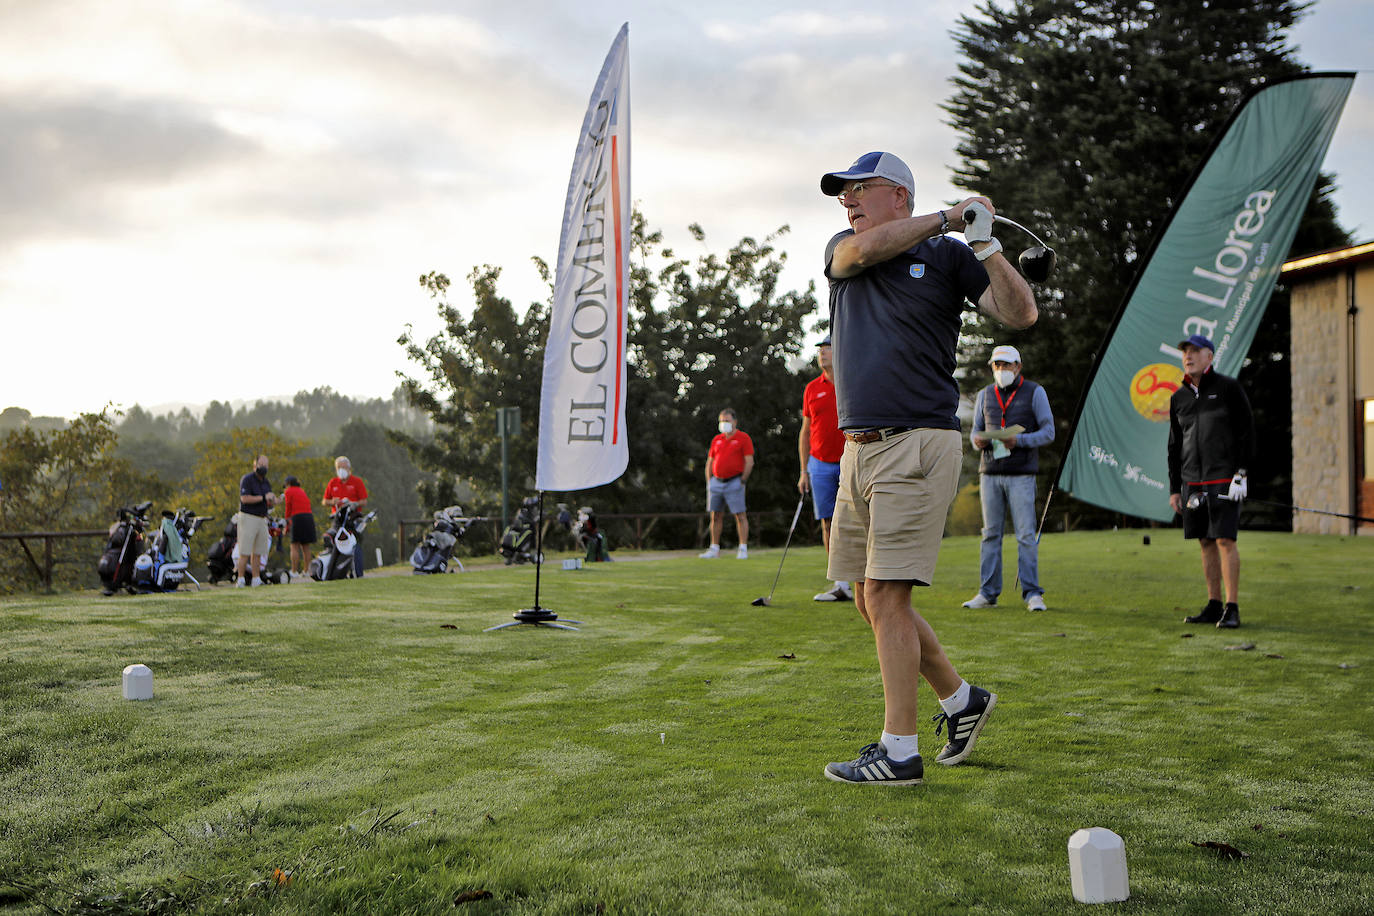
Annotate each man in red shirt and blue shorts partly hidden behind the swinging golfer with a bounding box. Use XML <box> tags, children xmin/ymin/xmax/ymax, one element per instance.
<box><xmin>797</xmin><ymin>335</ymin><xmax>853</xmax><ymax>602</ymax></box>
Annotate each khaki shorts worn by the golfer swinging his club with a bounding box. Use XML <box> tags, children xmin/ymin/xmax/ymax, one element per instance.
<box><xmin>827</xmin><ymin>430</ymin><xmax>963</xmax><ymax>585</ymax></box>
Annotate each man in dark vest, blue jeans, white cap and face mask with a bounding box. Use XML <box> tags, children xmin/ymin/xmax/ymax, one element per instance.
<box><xmin>963</xmin><ymin>346</ymin><xmax>1054</xmax><ymax>611</ymax></box>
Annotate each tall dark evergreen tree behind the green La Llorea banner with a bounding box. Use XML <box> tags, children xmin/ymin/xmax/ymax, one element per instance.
<box><xmin>944</xmin><ymin>0</ymin><xmax>1345</xmax><ymax>519</ymax></box>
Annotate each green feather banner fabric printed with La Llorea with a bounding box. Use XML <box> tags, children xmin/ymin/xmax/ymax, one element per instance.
<box><xmin>1057</xmin><ymin>73</ymin><xmax>1355</xmax><ymax>522</ymax></box>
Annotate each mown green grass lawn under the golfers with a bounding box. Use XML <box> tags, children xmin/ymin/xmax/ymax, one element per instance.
<box><xmin>0</xmin><ymin>530</ymin><xmax>1374</xmax><ymax>915</ymax></box>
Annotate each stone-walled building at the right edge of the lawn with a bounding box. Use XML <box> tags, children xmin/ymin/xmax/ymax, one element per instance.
<box><xmin>1282</xmin><ymin>242</ymin><xmax>1374</xmax><ymax>534</ymax></box>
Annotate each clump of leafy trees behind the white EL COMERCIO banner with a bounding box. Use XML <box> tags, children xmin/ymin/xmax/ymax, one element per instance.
<box><xmin>398</xmin><ymin>213</ymin><xmax>816</xmax><ymax>543</ymax></box>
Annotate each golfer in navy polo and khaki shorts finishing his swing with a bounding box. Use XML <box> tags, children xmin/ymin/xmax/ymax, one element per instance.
<box><xmin>820</xmin><ymin>152</ymin><xmax>1037</xmax><ymax>786</ymax></box>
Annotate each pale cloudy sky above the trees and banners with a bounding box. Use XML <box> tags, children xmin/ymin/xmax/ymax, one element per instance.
<box><xmin>0</xmin><ymin>0</ymin><xmax>1374</xmax><ymax>416</ymax></box>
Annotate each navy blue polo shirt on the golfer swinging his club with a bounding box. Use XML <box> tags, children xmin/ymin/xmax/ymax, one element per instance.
<box><xmin>826</xmin><ymin>229</ymin><xmax>989</xmax><ymax>430</ymax></box>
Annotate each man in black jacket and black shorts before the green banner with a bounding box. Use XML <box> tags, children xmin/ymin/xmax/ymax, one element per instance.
<box><xmin>1169</xmin><ymin>334</ymin><xmax>1254</xmax><ymax>628</ymax></box>
